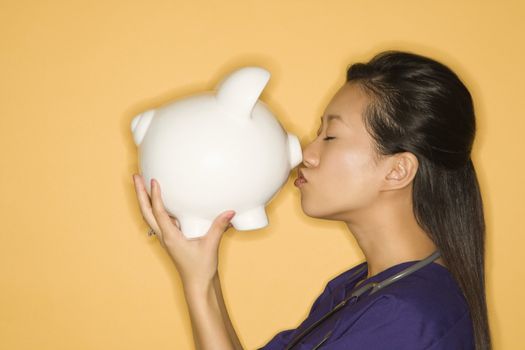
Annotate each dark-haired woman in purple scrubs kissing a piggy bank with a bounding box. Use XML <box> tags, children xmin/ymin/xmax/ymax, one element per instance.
<box><xmin>134</xmin><ymin>51</ymin><xmax>491</xmax><ymax>350</ymax></box>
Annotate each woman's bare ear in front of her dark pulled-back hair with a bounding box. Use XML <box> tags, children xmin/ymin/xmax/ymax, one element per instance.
<box><xmin>383</xmin><ymin>152</ymin><xmax>419</xmax><ymax>191</ymax></box>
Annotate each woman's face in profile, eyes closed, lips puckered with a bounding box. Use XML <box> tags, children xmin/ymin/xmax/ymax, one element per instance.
<box><xmin>300</xmin><ymin>83</ymin><xmax>384</xmax><ymax>221</ymax></box>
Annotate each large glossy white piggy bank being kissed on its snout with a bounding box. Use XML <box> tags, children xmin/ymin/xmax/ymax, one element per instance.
<box><xmin>131</xmin><ymin>67</ymin><xmax>302</xmax><ymax>238</ymax></box>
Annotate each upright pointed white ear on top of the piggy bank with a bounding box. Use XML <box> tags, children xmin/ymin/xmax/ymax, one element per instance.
<box><xmin>217</xmin><ymin>67</ymin><xmax>270</xmax><ymax>117</ymax></box>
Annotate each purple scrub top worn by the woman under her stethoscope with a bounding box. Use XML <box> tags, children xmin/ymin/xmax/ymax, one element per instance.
<box><xmin>259</xmin><ymin>261</ymin><xmax>474</xmax><ymax>350</ymax></box>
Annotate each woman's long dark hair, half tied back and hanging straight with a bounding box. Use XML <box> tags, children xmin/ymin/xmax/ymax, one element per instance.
<box><xmin>346</xmin><ymin>51</ymin><xmax>491</xmax><ymax>350</ymax></box>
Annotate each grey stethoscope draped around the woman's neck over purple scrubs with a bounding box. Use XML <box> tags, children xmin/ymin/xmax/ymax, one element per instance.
<box><xmin>285</xmin><ymin>250</ymin><xmax>441</xmax><ymax>350</ymax></box>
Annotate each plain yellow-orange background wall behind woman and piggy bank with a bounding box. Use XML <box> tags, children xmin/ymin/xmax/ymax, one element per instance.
<box><xmin>0</xmin><ymin>0</ymin><xmax>525</xmax><ymax>350</ymax></box>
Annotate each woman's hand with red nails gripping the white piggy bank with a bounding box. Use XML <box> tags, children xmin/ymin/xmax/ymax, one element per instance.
<box><xmin>133</xmin><ymin>174</ymin><xmax>235</xmax><ymax>288</ymax></box>
